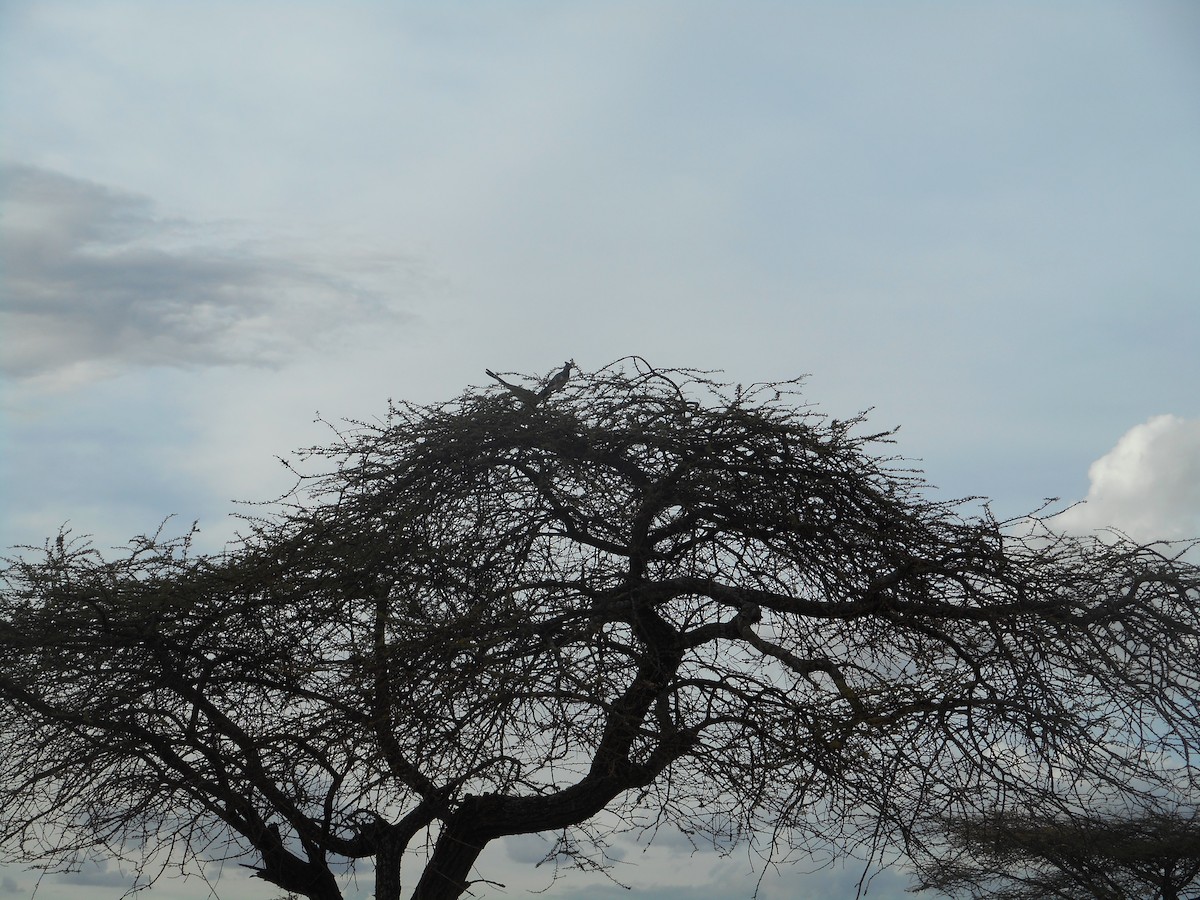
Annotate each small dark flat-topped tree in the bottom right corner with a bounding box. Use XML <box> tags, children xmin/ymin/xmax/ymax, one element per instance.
<box><xmin>919</xmin><ymin>809</ymin><xmax>1200</xmax><ymax>900</ymax></box>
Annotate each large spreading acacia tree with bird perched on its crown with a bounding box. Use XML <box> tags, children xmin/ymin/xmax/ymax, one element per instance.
<box><xmin>0</xmin><ymin>358</ymin><xmax>1200</xmax><ymax>900</ymax></box>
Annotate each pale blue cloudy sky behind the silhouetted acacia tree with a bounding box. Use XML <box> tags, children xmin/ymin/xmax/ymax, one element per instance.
<box><xmin>0</xmin><ymin>0</ymin><xmax>1200</xmax><ymax>900</ymax></box>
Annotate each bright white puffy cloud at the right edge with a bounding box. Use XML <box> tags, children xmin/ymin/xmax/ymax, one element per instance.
<box><xmin>1056</xmin><ymin>415</ymin><xmax>1200</xmax><ymax>541</ymax></box>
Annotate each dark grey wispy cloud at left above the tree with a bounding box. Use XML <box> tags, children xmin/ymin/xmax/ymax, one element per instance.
<box><xmin>0</xmin><ymin>164</ymin><xmax>415</xmax><ymax>378</ymax></box>
